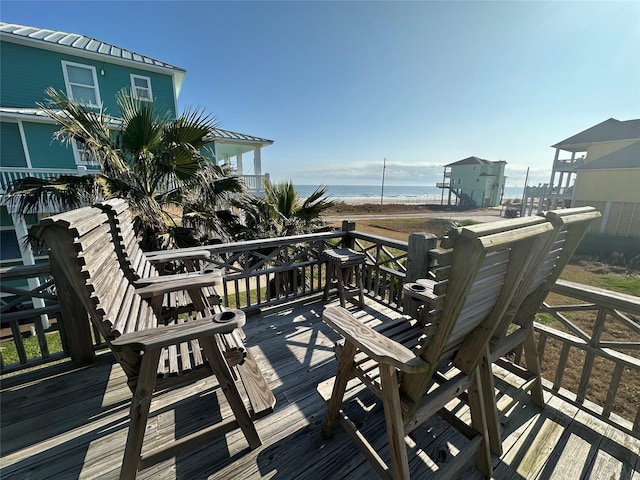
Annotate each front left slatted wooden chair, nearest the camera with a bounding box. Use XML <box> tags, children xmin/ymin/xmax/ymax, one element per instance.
<box><xmin>32</xmin><ymin>207</ymin><xmax>275</xmax><ymax>478</ymax></box>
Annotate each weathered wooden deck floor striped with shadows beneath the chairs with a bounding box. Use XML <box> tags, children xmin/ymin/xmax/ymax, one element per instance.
<box><xmin>0</xmin><ymin>296</ymin><xmax>640</xmax><ymax>480</ymax></box>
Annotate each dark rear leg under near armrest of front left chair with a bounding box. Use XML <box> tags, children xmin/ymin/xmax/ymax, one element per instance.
<box><xmin>120</xmin><ymin>349</ymin><xmax>161</xmax><ymax>480</ymax></box>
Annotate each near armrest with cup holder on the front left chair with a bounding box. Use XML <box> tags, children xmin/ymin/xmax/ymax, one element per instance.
<box><xmin>111</xmin><ymin>310</ymin><xmax>246</xmax><ymax>351</ymax></box>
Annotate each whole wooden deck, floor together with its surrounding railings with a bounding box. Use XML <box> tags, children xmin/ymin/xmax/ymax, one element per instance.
<box><xmin>0</xmin><ymin>229</ymin><xmax>640</xmax><ymax>479</ymax></box>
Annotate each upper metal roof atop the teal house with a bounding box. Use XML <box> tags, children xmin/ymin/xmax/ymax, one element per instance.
<box><xmin>0</xmin><ymin>22</ymin><xmax>185</xmax><ymax>74</ymax></box>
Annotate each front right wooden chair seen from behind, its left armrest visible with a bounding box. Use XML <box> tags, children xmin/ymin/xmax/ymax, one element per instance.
<box><xmin>318</xmin><ymin>218</ymin><xmax>553</xmax><ymax>479</ymax></box>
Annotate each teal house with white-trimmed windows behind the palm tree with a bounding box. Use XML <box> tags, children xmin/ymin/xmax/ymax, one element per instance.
<box><xmin>0</xmin><ymin>22</ymin><xmax>273</xmax><ymax>266</ymax></box>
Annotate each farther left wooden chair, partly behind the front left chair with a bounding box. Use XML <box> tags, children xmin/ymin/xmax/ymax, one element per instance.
<box><xmin>95</xmin><ymin>198</ymin><xmax>222</xmax><ymax>315</ymax></box>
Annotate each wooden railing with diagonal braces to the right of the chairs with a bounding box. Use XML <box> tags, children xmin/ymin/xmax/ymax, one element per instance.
<box><xmin>535</xmin><ymin>280</ymin><xmax>640</xmax><ymax>438</ymax></box>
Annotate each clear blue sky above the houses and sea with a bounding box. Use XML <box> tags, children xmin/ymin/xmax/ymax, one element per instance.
<box><xmin>0</xmin><ymin>0</ymin><xmax>640</xmax><ymax>186</ymax></box>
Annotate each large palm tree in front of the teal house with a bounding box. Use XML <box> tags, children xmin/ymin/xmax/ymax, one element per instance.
<box><xmin>6</xmin><ymin>88</ymin><xmax>245</xmax><ymax>249</ymax></box>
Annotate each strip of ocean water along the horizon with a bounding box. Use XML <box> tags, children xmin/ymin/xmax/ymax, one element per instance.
<box><xmin>295</xmin><ymin>185</ymin><xmax>522</xmax><ymax>204</ymax></box>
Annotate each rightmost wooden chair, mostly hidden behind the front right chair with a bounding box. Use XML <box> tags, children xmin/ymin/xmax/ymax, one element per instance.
<box><xmin>483</xmin><ymin>207</ymin><xmax>601</xmax><ymax>455</ymax></box>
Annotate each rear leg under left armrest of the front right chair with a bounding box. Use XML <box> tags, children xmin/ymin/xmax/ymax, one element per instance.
<box><xmin>380</xmin><ymin>364</ymin><xmax>409</xmax><ymax>480</ymax></box>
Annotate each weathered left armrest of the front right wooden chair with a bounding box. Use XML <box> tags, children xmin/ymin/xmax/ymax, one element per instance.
<box><xmin>322</xmin><ymin>307</ymin><xmax>431</xmax><ymax>373</ymax></box>
